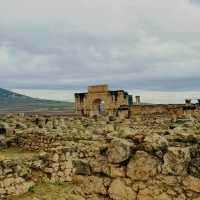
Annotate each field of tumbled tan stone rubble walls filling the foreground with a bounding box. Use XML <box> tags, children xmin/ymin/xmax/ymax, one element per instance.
<box><xmin>0</xmin><ymin>110</ymin><xmax>200</xmax><ymax>200</ymax></box>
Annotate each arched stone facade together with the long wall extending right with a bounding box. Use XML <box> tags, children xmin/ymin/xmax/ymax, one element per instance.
<box><xmin>75</xmin><ymin>85</ymin><xmax>200</xmax><ymax>118</ymax></box>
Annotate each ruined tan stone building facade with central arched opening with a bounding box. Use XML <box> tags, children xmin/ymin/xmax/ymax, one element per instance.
<box><xmin>75</xmin><ymin>85</ymin><xmax>133</xmax><ymax>116</ymax></box>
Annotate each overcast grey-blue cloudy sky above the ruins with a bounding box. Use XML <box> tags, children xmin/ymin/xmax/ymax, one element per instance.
<box><xmin>0</xmin><ymin>0</ymin><xmax>200</xmax><ymax>102</ymax></box>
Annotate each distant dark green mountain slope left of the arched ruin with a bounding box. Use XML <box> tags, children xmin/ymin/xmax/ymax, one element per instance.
<box><xmin>0</xmin><ymin>88</ymin><xmax>74</xmax><ymax>112</ymax></box>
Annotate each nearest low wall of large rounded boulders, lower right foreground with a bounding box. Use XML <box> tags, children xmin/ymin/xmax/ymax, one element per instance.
<box><xmin>23</xmin><ymin>138</ymin><xmax>200</xmax><ymax>200</ymax></box>
